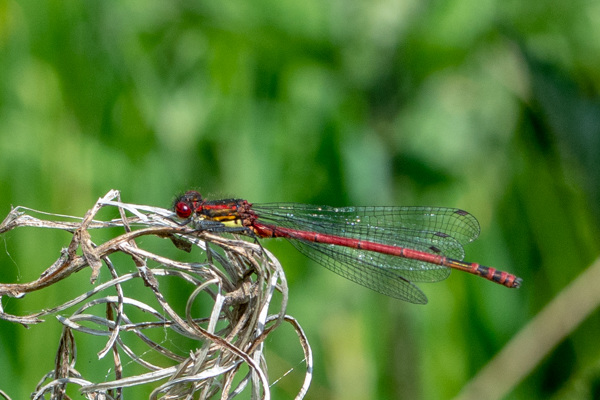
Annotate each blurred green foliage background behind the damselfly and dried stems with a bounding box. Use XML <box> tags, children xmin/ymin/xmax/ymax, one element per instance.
<box><xmin>0</xmin><ymin>0</ymin><xmax>600</xmax><ymax>399</ymax></box>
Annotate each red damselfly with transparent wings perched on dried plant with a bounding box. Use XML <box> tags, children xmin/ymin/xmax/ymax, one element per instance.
<box><xmin>173</xmin><ymin>191</ymin><xmax>522</xmax><ymax>304</ymax></box>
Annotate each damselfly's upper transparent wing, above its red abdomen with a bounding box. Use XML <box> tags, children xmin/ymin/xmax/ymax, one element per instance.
<box><xmin>252</xmin><ymin>203</ymin><xmax>480</xmax><ymax>260</ymax></box>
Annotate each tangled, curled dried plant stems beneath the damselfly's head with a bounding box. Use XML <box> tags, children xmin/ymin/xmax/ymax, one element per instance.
<box><xmin>0</xmin><ymin>190</ymin><xmax>312</xmax><ymax>399</ymax></box>
